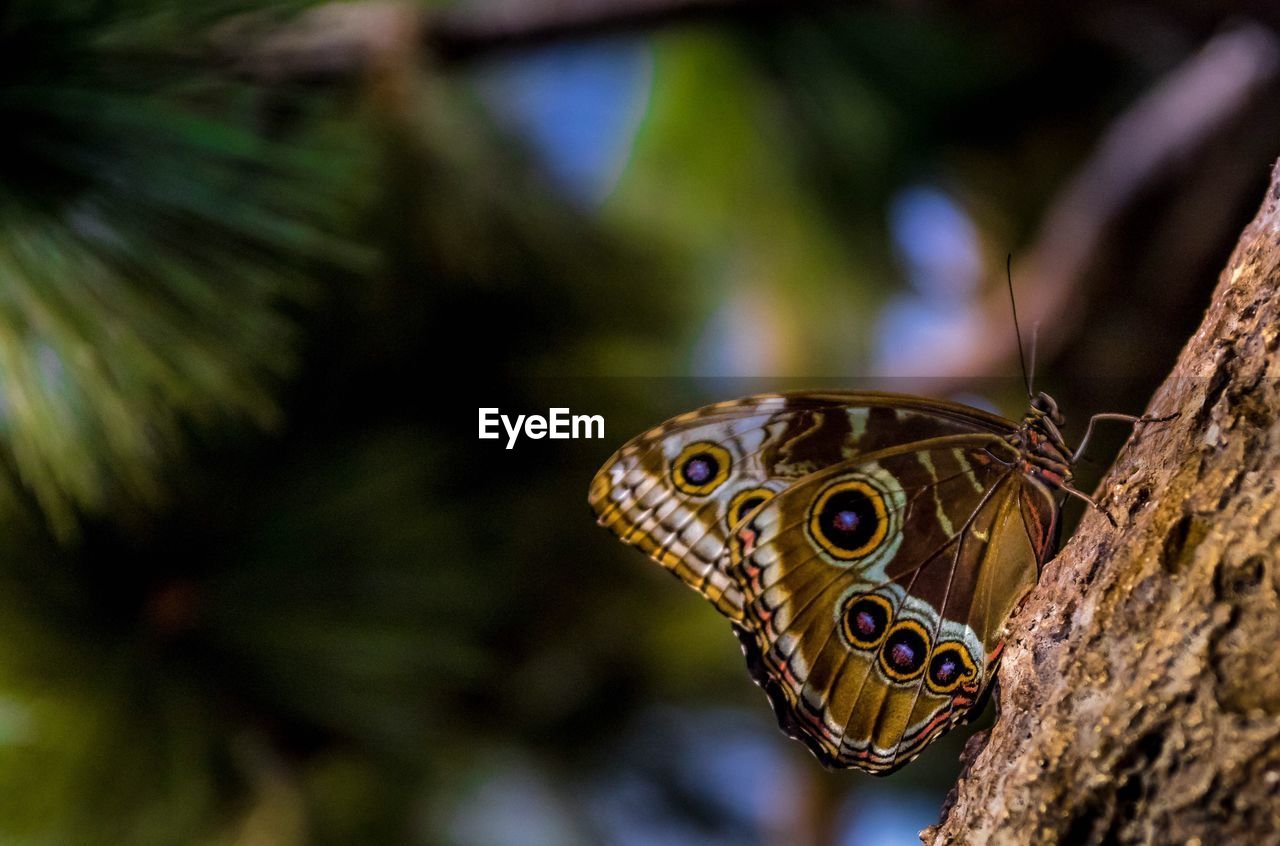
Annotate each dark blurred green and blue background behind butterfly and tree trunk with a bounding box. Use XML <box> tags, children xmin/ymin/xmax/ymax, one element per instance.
<box><xmin>0</xmin><ymin>0</ymin><xmax>1280</xmax><ymax>846</ymax></box>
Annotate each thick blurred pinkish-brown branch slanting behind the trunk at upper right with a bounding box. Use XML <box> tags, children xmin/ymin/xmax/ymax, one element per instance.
<box><xmin>906</xmin><ymin>26</ymin><xmax>1280</xmax><ymax>393</ymax></box>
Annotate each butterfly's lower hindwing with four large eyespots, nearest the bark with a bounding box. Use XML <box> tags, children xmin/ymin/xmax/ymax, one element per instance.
<box><xmin>723</xmin><ymin>435</ymin><xmax>1057</xmax><ymax>773</ymax></box>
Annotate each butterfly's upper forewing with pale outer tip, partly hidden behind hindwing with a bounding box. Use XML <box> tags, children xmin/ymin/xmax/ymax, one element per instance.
<box><xmin>589</xmin><ymin>392</ymin><xmax>1012</xmax><ymax>622</ymax></box>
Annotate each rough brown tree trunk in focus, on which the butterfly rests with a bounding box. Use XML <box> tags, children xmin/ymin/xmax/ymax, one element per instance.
<box><xmin>922</xmin><ymin>165</ymin><xmax>1280</xmax><ymax>846</ymax></box>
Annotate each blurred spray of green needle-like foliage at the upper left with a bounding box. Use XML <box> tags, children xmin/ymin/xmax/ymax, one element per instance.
<box><xmin>0</xmin><ymin>3</ymin><xmax>371</xmax><ymax>538</ymax></box>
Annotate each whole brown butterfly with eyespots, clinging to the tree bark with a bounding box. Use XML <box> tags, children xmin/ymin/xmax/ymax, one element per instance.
<box><xmin>589</xmin><ymin>390</ymin><xmax>1149</xmax><ymax>773</ymax></box>
